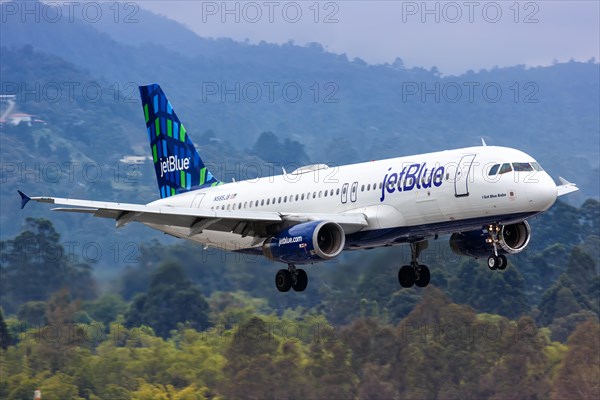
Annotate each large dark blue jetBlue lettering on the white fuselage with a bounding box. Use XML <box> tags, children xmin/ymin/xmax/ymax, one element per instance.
<box><xmin>379</xmin><ymin>162</ymin><xmax>444</xmax><ymax>202</ymax></box>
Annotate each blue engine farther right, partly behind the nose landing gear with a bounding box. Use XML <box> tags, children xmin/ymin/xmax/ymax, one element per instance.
<box><xmin>450</xmin><ymin>221</ymin><xmax>531</xmax><ymax>258</ymax></box>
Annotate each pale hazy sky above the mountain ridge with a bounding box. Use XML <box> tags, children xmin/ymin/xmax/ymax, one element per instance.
<box><xmin>140</xmin><ymin>0</ymin><xmax>600</xmax><ymax>74</ymax></box>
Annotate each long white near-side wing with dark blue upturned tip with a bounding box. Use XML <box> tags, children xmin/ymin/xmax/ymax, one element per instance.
<box><xmin>19</xmin><ymin>191</ymin><xmax>367</xmax><ymax>236</ymax></box>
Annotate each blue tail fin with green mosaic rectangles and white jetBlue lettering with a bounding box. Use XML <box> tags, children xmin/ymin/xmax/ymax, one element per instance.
<box><xmin>140</xmin><ymin>83</ymin><xmax>221</xmax><ymax>199</ymax></box>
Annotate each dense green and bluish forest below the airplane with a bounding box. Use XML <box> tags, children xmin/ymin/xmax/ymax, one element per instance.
<box><xmin>0</xmin><ymin>196</ymin><xmax>600</xmax><ymax>399</ymax></box>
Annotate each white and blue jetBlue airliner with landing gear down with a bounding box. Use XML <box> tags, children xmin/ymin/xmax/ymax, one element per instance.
<box><xmin>19</xmin><ymin>84</ymin><xmax>578</xmax><ymax>292</ymax></box>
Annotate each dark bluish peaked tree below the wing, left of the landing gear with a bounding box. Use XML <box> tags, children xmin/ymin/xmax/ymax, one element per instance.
<box><xmin>125</xmin><ymin>262</ymin><xmax>209</xmax><ymax>338</ymax></box>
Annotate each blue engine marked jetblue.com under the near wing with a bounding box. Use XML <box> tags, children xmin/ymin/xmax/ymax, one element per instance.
<box><xmin>263</xmin><ymin>221</ymin><xmax>346</xmax><ymax>264</ymax></box>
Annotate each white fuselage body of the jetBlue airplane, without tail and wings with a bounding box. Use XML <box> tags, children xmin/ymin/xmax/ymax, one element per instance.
<box><xmin>149</xmin><ymin>146</ymin><xmax>557</xmax><ymax>250</ymax></box>
